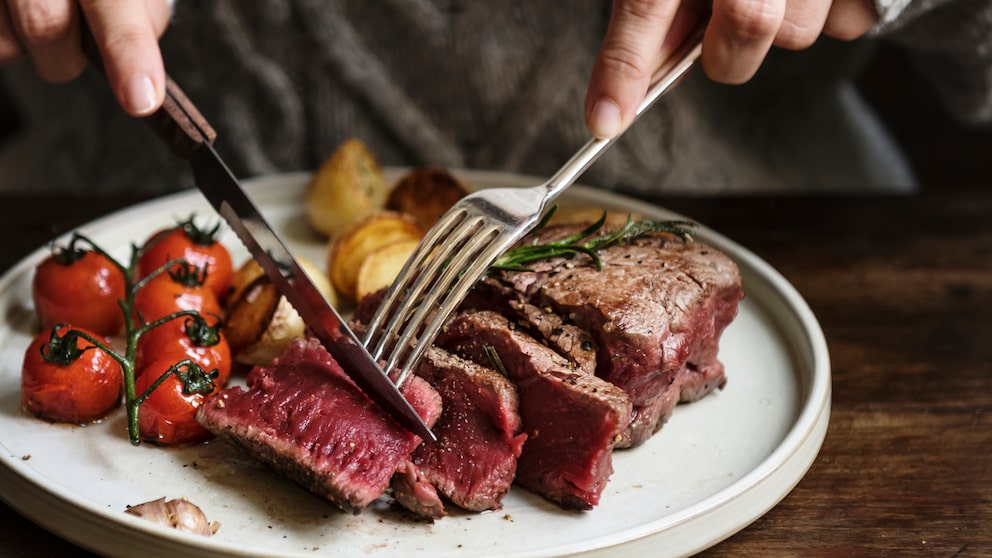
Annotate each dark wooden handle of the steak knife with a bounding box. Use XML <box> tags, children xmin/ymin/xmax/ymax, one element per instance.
<box><xmin>83</xmin><ymin>25</ymin><xmax>217</xmax><ymax>160</ymax></box>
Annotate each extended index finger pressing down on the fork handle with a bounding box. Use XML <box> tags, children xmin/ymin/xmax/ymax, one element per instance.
<box><xmin>585</xmin><ymin>0</ymin><xmax>677</xmax><ymax>137</ymax></box>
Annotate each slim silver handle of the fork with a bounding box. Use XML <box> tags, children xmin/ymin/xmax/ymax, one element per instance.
<box><xmin>542</xmin><ymin>24</ymin><xmax>706</xmax><ymax>203</ymax></box>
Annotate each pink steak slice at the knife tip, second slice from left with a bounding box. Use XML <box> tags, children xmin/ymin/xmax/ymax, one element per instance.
<box><xmin>393</xmin><ymin>347</ymin><xmax>527</xmax><ymax>519</ymax></box>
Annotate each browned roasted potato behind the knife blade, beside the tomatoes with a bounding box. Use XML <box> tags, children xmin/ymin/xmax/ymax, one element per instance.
<box><xmin>224</xmin><ymin>255</ymin><xmax>337</xmax><ymax>365</ymax></box>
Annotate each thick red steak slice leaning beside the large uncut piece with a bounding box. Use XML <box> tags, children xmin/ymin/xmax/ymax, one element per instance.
<box><xmin>437</xmin><ymin>311</ymin><xmax>631</xmax><ymax>509</ymax></box>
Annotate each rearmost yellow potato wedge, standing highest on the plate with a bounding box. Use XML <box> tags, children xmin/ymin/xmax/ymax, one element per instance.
<box><xmin>304</xmin><ymin>139</ymin><xmax>389</xmax><ymax>236</ymax></box>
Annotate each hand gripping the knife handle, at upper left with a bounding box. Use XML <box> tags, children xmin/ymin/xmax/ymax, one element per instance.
<box><xmin>0</xmin><ymin>0</ymin><xmax>170</xmax><ymax>116</ymax></box>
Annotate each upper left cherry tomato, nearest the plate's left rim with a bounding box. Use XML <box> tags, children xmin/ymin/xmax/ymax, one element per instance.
<box><xmin>31</xmin><ymin>245</ymin><xmax>125</xmax><ymax>335</ymax></box>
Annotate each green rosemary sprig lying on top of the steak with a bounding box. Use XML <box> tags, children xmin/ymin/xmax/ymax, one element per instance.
<box><xmin>490</xmin><ymin>209</ymin><xmax>694</xmax><ymax>271</ymax></box>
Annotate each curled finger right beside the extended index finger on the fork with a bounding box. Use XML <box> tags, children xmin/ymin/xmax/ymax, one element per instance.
<box><xmin>701</xmin><ymin>0</ymin><xmax>785</xmax><ymax>83</ymax></box>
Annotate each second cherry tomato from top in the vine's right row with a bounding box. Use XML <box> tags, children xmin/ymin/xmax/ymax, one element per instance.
<box><xmin>132</xmin><ymin>265</ymin><xmax>221</xmax><ymax>334</ymax></box>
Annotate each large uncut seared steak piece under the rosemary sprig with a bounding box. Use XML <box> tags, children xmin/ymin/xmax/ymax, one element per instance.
<box><xmin>496</xmin><ymin>225</ymin><xmax>744</xmax><ymax>446</ymax></box>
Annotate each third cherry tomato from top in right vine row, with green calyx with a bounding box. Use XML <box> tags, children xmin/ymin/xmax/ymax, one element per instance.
<box><xmin>134</xmin><ymin>316</ymin><xmax>232</xmax><ymax>386</ymax></box>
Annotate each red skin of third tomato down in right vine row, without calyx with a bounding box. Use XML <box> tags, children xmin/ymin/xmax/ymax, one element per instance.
<box><xmin>134</xmin><ymin>317</ymin><xmax>233</xmax><ymax>386</ymax></box>
